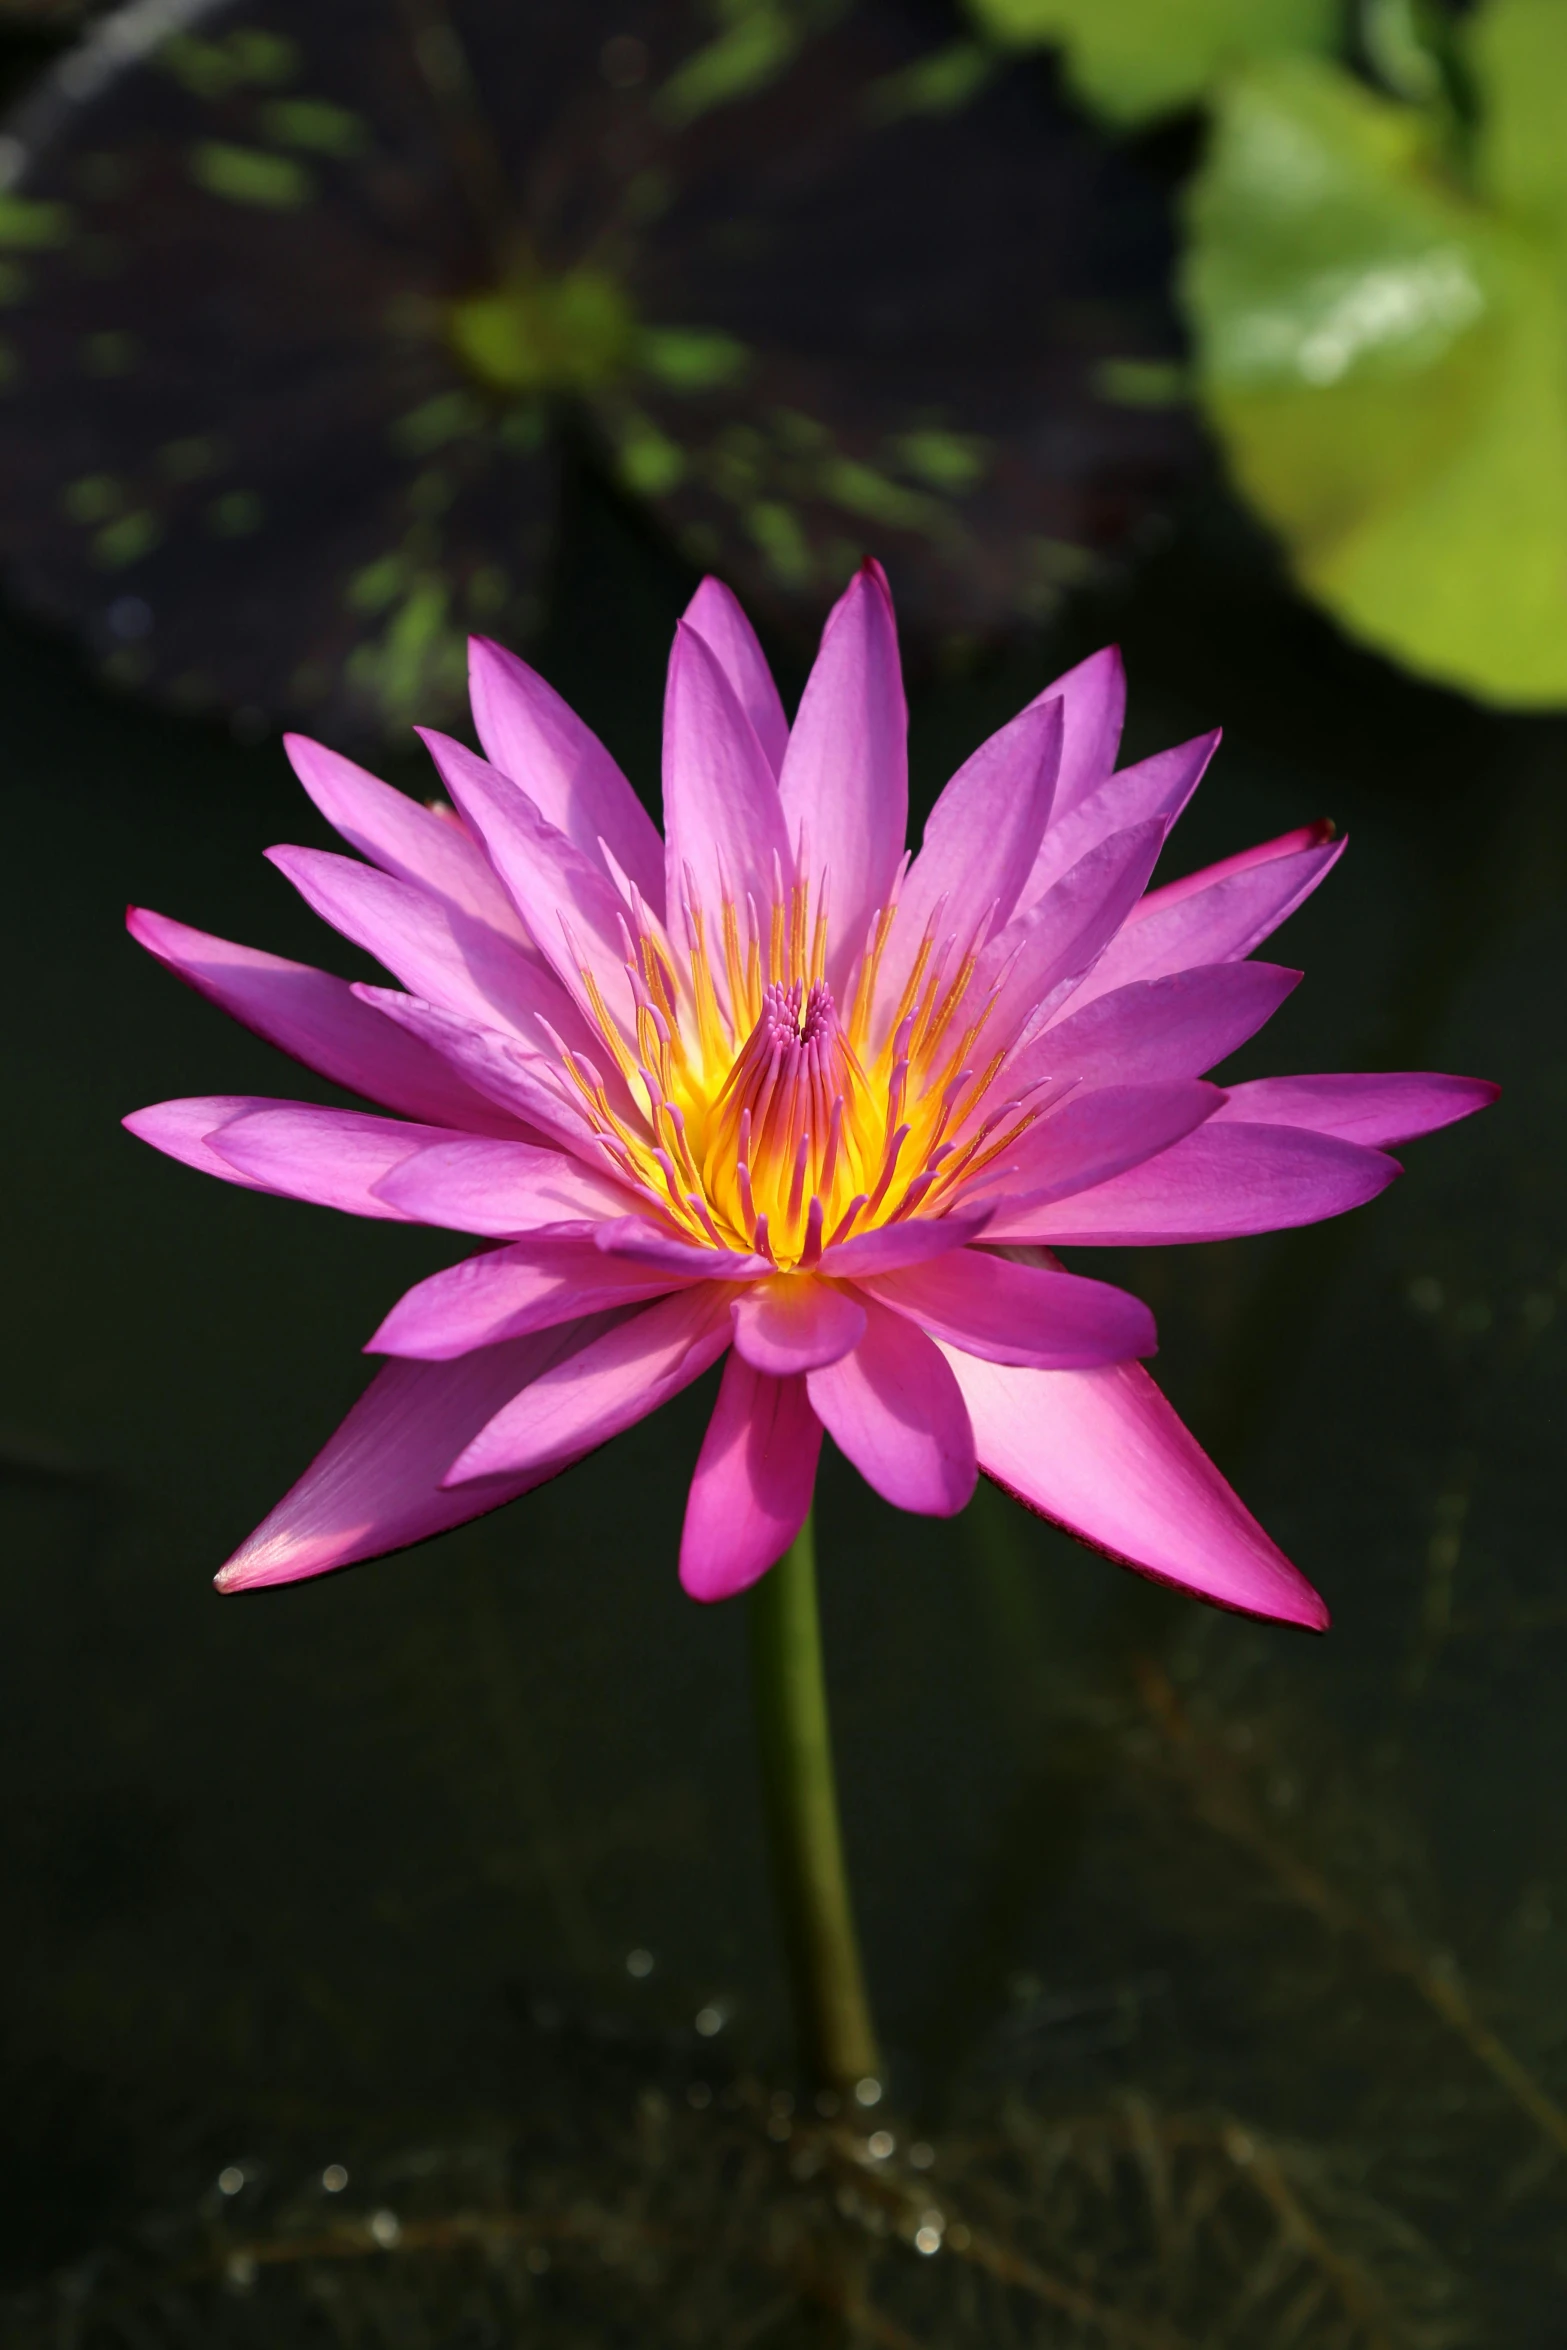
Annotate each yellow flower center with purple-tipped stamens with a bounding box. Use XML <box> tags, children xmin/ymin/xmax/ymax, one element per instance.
<box><xmin>564</xmin><ymin>884</ymin><xmax>1034</xmax><ymax>1271</ymax></box>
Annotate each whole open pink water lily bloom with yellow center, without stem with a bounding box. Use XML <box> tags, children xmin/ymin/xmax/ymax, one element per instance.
<box><xmin>127</xmin><ymin>564</ymin><xmax>1497</xmax><ymax>1626</ymax></box>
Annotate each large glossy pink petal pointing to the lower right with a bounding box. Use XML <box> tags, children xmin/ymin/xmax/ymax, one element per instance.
<box><xmin>947</xmin><ymin>1349</ymin><xmax>1327</xmax><ymax>1631</ymax></box>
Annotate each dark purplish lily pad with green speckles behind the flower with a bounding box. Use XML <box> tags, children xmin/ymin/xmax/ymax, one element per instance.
<box><xmin>0</xmin><ymin>0</ymin><xmax>1196</xmax><ymax>738</ymax></box>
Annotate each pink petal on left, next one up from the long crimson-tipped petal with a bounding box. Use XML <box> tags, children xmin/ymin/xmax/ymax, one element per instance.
<box><xmin>268</xmin><ymin>848</ymin><xmax>580</xmax><ymax>1043</ymax></box>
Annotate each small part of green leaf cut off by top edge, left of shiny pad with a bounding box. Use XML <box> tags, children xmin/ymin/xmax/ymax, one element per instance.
<box><xmin>970</xmin><ymin>0</ymin><xmax>1344</xmax><ymax>122</ymax></box>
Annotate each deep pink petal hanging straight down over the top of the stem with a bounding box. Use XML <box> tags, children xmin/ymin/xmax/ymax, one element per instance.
<box><xmin>679</xmin><ymin>1354</ymin><xmax>822</xmax><ymax>1600</ymax></box>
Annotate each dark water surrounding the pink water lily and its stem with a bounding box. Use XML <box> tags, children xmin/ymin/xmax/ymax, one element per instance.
<box><xmin>0</xmin><ymin>448</ymin><xmax>1567</xmax><ymax>2345</ymax></box>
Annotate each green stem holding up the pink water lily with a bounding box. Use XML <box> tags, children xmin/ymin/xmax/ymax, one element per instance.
<box><xmin>747</xmin><ymin>1518</ymin><xmax>881</xmax><ymax>2092</ymax></box>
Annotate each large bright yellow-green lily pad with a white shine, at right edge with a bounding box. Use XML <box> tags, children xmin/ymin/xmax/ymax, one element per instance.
<box><xmin>1184</xmin><ymin>61</ymin><xmax>1567</xmax><ymax>707</ymax></box>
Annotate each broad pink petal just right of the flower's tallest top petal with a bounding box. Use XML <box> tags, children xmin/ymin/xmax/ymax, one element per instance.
<box><xmin>881</xmin><ymin>703</ymin><xmax>1062</xmax><ymax>999</ymax></box>
